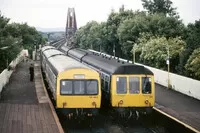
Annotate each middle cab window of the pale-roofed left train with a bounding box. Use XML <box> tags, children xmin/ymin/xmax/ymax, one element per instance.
<box><xmin>74</xmin><ymin>81</ymin><xmax>85</xmax><ymax>94</ymax></box>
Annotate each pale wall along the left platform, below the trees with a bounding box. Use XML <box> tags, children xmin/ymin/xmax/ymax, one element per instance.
<box><xmin>0</xmin><ymin>50</ymin><xmax>28</xmax><ymax>93</ymax></box>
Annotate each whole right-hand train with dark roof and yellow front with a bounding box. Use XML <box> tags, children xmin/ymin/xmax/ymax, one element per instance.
<box><xmin>60</xmin><ymin>46</ymin><xmax>155</xmax><ymax>118</ymax></box>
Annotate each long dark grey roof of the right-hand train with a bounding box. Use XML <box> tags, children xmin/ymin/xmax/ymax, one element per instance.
<box><xmin>61</xmin><ymin>46</ymin><xmax>153</xmax><ymax>75</ymax></box>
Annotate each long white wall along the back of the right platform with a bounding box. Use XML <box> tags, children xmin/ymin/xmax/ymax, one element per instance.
<box><xmin>90</xmin><ymin>50</ymin><xmax>200</xmax><ymax>100</ymax></box>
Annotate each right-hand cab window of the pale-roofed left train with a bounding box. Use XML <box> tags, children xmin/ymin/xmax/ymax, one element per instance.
<box><xmin>86</xmin><ymin>80</ymin><xmax>98</xmax><ymax>94</ymax></box>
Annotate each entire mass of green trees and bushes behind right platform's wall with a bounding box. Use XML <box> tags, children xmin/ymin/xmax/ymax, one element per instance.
<box><xmin>76</xmin><ymin>0</ymin><xmax>200</xmax><ymax>79</ymax></box>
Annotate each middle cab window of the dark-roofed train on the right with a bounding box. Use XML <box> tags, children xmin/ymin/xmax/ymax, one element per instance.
<box><xmin>129</xmin><ymin>77</ymin><xmax>140</xmax><ymax>94</ymax></box>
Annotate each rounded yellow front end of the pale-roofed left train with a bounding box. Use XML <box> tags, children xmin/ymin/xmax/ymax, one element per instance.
<box><xmin>56</xmin><ymin>68</ymin><xmax>101</xmax><ymax>117</ymax></box>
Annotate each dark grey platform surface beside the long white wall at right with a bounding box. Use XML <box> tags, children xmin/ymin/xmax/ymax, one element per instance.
<box><xmin>155</xmin><ymin>84</ymin><xmax>200</xmax><ymax>132</ymax></box>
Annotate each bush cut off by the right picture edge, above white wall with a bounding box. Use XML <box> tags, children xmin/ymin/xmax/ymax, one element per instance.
<box><xmin>185</xmin><ymin>48</ymin><xmax>200</xmax><ymax>80</ymax></box>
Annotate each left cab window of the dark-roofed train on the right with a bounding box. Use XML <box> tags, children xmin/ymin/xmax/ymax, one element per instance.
<box><xmin>117</xmin><ymin>77</ymin><xmax>127</xmax><ymax>94</ymax></box>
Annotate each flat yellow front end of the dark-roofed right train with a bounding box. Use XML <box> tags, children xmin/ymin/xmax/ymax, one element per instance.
<box><xmin>110</xmin><ymin>70</ymin><xmax>155</xmax><ymax>117</ymax></box>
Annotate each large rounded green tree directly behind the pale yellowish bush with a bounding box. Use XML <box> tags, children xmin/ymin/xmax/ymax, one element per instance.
<box><xmin>117</xmin><ymin>12</ymin><xmax>185</xmax><ymax>59</ymax></box>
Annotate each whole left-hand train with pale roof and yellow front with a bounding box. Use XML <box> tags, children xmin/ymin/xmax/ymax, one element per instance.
<box><xmin>41</xmin><ymin>46</ymin><xmax>101</xmax><ymax>118</ymax></box>
